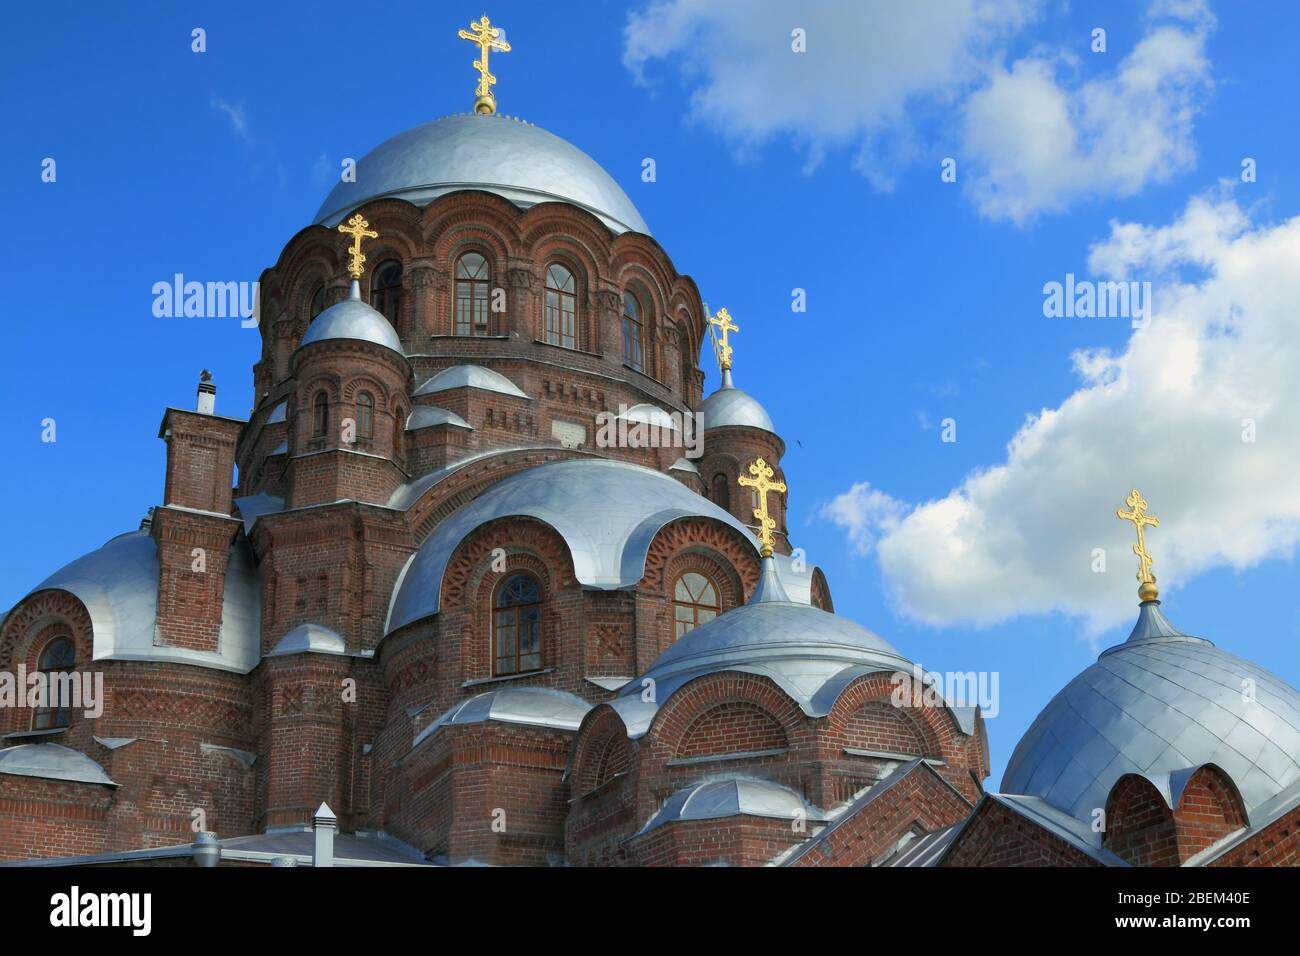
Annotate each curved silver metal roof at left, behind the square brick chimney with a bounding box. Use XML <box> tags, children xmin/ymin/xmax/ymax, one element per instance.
<box><xmin>29</xmin><ymin>531</ymin><xmax>261</xmax><ymax>674</ymax></box>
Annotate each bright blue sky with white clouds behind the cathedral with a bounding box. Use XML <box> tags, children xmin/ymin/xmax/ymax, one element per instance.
<box><xmin>0</xmin><ymin>0</ymin><xmax>1300</xmax><ymax>787</ymax></box>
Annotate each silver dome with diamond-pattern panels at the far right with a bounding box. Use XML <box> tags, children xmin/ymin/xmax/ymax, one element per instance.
<box><xmin>1002</xmin><ymin>602</ymin><xmax>1300</xmax><ymax>819</ymax></box>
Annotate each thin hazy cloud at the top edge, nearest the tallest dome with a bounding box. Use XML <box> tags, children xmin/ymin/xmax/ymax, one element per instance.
<box><xmin>623</xmin><ymin>0</ymin><xmax>1040</xmax><ymax>186</ymax></box>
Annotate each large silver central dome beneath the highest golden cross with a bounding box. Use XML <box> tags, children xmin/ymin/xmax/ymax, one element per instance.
<box><xmin>316</xmin><ymin>113</ymin><xmax>650</xmax><ymax>234</ymax></box>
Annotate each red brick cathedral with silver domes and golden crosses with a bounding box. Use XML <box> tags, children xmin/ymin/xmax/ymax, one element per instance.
<box><xmin>0</xmin><ymin>17</ymin><xmax>1300</xmax><ymax>866</ymax></box>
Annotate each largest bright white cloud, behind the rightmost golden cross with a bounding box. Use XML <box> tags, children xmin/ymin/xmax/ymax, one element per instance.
<box><xmin>826</xmin><ymin>196</ymin><xmax>1300</xmax><ymax>632</ymax></box>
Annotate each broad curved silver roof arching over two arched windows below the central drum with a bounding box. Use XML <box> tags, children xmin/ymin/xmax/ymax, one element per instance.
<box><xmin>385</xmin><ymin>459</ymin><xmax>758</xmax><ymax>633</ymax></box>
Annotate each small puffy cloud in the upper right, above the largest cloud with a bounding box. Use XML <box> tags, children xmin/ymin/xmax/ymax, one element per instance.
<box><xmin>962</xmin><ymin>4</ymin><xmax>1213</xmax><ymax>224</ymax></box>
